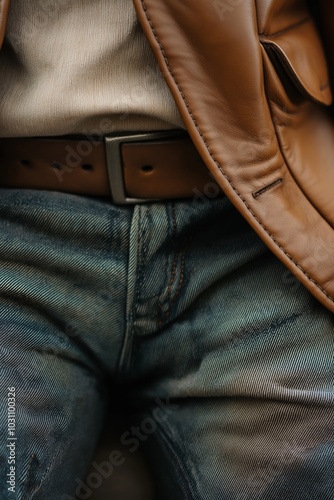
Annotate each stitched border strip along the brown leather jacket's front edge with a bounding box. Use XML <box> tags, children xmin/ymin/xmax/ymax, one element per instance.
<box><xmin>140</xmin><ymin>0</ymin><xmax>334</xmax><ymax>303</ymax></box>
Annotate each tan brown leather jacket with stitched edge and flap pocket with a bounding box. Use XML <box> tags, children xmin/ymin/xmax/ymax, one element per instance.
<box><xmin>0</xmin><ymin>0</ymin><xmax>334</xmax><ymax>312</ymax></box>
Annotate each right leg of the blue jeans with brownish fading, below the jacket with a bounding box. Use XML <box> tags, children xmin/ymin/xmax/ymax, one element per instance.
<box><xmin>124</xmin><ymin>197</ymin><xmax>334</xmax><ymax>500</ymax></box>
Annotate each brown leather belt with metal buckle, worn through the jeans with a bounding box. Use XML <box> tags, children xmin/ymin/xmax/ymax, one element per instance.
<box><xmin>0</xmin><ymin>131</ymin><xmax>222</xmax><ymax>204</ymax></box>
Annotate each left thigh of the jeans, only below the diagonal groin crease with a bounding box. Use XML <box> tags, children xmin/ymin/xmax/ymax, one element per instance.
<box><xmin>0</xmin><ymin>299</ymin><xmax>107</xmax><ymax>500</ymax></box>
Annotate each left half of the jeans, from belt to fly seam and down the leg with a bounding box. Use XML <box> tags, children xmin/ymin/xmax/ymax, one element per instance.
<box><xmin>0</xmin><ymin>189</ymin><xmax>131</xmax><ymax>500</ymax></box>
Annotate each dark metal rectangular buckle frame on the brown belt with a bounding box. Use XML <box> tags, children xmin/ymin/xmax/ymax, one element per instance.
<box><xmin>104</xmin><ymin>130</ymin><xmax>182</xmax><ymax>205</ymax></box>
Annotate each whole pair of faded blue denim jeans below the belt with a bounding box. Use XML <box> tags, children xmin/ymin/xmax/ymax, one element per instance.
<box><xmin>0</xmin><ymin>189</ymin><xmax>334</xmax><ymax>500</ymax></box>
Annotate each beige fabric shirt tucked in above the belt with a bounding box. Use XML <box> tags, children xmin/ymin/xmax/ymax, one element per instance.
<box><xmin>0</xmin><ymin>0</ymin><xmax>183</xmax><ymax>137</ymax></box>
